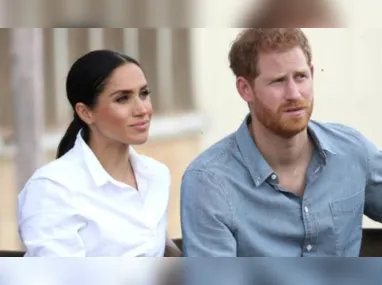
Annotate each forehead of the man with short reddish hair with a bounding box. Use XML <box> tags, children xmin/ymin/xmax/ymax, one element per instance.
<box><xmin>257</xmin><ymin>47</ymin><xmax>309</xmax><ymax>76</ymax></box>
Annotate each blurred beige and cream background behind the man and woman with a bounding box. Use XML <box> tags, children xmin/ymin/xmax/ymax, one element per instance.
<box><xmin>0</xmin><ymin>0</ymin><xmax>382</xmax><ymax>253</ymax></box>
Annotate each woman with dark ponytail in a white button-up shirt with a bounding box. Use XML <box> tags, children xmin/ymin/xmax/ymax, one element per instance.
<box><xmin>18</xmin><ymin>50</ymin><xmax>180</xmax><ymax>257</ymax></box>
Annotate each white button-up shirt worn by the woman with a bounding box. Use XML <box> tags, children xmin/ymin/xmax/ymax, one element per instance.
<box><xmin>18</xmin><ymin>132</ymin><xmax>171</xmax><ymax>257</ymax></box>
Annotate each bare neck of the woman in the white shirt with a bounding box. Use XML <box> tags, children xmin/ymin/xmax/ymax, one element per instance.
<box><xmin>89</xmin><ymin>133</ymin><xmax>133</xmax><ymax>182</ymax></box>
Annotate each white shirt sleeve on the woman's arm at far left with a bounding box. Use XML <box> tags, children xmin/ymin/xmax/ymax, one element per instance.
<box><xmin>17</xmin><ymin>178</ymin><xmax>86</xmax><ymax>257</ymax></box>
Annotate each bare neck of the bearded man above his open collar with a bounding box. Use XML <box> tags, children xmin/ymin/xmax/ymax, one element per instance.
<box><xmin>249</xmin><ymin>116</ymin><xmax>313</xmax><ymax>170</ymax></box>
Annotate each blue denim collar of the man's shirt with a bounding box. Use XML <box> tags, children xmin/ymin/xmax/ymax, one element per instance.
<box><xmin>235</xmin><ymin>114</ymin><xmax>335</xmax><ymax>186</ymax></box>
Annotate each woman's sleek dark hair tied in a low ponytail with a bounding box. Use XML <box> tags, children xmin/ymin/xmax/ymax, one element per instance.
<box><xmin>56</xmin><ymin>50</ymin><xmax>140</xmax><ymax>158</ymax></box>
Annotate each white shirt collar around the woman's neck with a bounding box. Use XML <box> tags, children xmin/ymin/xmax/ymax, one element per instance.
<box><xmin>74</xmin><ymin>131</ymin><xmax>153</xmax><ymax>188</ymax></box>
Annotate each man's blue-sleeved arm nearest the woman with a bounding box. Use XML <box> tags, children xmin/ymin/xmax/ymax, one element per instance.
<box><xmin>181</xmin><ymin>170</ymin><xmax>237</xmax><ymax>257</ymax></box>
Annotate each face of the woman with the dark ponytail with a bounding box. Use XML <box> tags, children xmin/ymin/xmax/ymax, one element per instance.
<box><xmin>84</xmin><ymin>63</ymin><xmax>152</xmax><ymax>145</ymax></box>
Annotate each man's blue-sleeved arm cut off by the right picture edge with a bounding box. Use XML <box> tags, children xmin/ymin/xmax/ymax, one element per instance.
<box><xmin>365</xmin><ymin>136</ymin><xmax>382</xmax><ymax>222</ymax></box>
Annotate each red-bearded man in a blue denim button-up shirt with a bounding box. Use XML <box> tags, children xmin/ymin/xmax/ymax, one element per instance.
<box><xmin>181</xmin><ymin>28</ymin><xmax>382</xmax><ymax>257</ymax></box>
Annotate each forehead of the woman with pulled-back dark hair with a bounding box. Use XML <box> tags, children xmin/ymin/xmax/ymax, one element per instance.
<box><xmin>108</xmin><ymin>63</ymin><xmax>147</xmax><ymax>90</ymax></box>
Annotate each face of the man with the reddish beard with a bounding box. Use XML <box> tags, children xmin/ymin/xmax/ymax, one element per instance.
<box><xmin>248</xmin><ymin>47</ymin><xmax>313</xmax><ymax>138</ymax></box>
